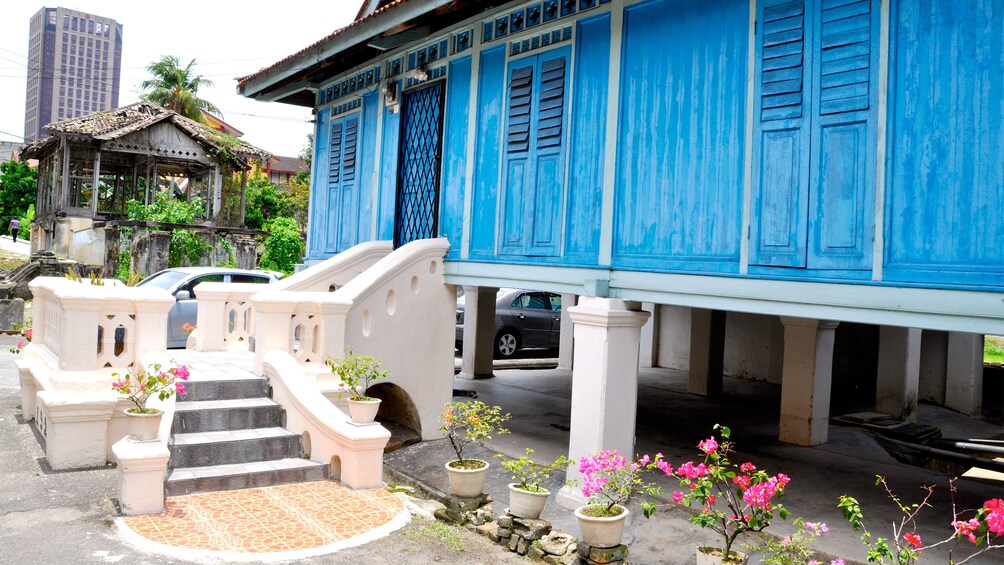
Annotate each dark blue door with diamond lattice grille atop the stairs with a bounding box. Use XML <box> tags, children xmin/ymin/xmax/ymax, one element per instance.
<box><xmin>394</xmin><ymin>80</ymin><xmax>443</xmax><ymax>247</ymax></box>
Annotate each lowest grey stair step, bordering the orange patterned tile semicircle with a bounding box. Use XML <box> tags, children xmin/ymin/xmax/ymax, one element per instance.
<box><xmin>164</xmin><ymin>458</ymin><xmax>328</xmax><ymax>497</ymax></box>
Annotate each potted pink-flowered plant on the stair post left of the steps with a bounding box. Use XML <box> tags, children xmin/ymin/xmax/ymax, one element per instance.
<box><xmin>111</xmin><ymin>363</ymin><xmax>189</xmax><ymax>441</ymax></box>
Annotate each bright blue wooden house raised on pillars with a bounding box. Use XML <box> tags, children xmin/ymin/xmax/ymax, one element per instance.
<box><xmin>239</xmin><ymin>0</ymin><xmax>1004</xmax><ymax>469</ymax></box>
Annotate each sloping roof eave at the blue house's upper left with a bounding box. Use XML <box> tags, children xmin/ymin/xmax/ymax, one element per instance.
<box><xmin>237</xmin><ymin>0</ymin><xmax>453</xmax><ymax>101</ymax></box>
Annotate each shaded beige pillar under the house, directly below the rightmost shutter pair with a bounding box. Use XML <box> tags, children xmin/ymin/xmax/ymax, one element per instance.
<box><xmin>779</xmin><ymin>317</ymin><xmax>838</xmax><ymax>446</ymax></box>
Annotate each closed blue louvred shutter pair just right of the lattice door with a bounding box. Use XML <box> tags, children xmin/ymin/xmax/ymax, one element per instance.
<box><xmin>499</xmin><ymin>49</ymin><xmax>568</xmax><ymax>257</ymax></box>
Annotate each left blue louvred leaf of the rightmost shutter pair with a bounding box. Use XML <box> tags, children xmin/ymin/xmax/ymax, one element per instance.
<box><xmin>750</xmin><ymin>0</ymin><xmax>811</xmax><ymax>267</ymax></box>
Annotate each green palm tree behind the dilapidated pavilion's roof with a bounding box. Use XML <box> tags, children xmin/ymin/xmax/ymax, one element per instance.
<box><xmin>140</xmin><ymin>55</ymin><xmax>220</xmax><ymax>122</ymax></box>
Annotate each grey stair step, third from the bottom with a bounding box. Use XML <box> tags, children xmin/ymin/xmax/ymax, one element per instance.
<box><xmin>171</xmin><ymin>398</ymin><xmax>282</xmax><ymax>434</ymax></box>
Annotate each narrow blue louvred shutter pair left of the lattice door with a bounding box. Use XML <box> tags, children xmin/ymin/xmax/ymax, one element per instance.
<box><xmin>323</xmin><ymin>113</ymin><xmax>359</xmax><ymax>254</ymax></box>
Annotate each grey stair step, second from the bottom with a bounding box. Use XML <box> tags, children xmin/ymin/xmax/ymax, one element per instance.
<box><xmin>171</xmin><ymin>428</ymin><xmax>300</xmax><ymax>468</ymax></box>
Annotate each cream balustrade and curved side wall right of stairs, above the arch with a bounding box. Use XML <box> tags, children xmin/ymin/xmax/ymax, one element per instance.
<box><xmin>250</xmin><ymin>239</ymin><xmax>456</xmax><ymax>439</ymax></box>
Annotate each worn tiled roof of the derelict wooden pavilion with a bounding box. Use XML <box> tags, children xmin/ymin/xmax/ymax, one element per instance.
<box><xmin>23</xmin><ymin>102</ymin><xmax>272</xmax><ymax>161</ymax></box>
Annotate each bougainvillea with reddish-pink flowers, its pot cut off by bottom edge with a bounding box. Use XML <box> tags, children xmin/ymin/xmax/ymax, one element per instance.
<box><xmin>659</xmin><ymin>423</ymin><xmax>790</xmax><ymax>565</ymax></box>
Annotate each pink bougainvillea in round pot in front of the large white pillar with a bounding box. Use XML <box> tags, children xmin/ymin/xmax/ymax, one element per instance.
<box><xmin>575</xmin><ymin>450</ymin><xmax>663</xmax><ymax>548</ymax></box>
